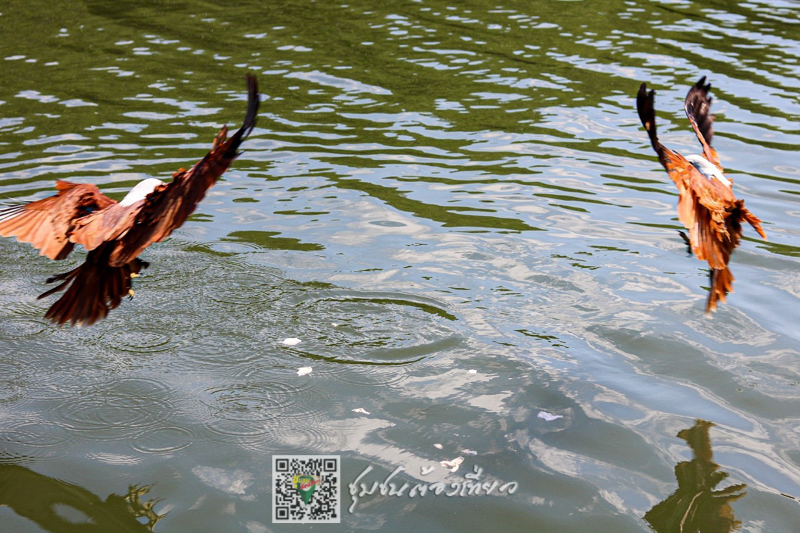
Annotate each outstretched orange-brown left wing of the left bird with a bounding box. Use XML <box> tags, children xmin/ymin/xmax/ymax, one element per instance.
<box><xmin>0</xmin><ymin>181</ymin><xmax>117</xmax><ymax>259</ymax></box>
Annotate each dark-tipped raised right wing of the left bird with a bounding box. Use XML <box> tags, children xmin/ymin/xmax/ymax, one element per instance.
<box><xmin>110</xmin><ymin>75</ymin><xmax>259</xmax><ymax>266</ymax></box>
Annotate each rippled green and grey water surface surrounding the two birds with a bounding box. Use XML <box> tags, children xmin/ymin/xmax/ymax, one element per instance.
<box><xmin>0</xmin><ymin>0</ymin><xmax>800</xmax><ymax>533</ymax></box>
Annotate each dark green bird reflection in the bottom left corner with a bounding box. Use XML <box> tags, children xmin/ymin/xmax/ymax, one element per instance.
<box><xmin>0</xmin><ymin>464</ymin><xmax>166</xmax><ymax>533</ymax></box>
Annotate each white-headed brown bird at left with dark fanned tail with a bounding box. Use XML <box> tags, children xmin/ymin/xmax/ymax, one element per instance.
<box><xmin>0</xmin><ymin>75</ymin><xmax>259</xmax><ymax>325</ymax></box>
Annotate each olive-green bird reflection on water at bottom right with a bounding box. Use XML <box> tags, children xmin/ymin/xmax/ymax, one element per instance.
<box><xmin>644</xmin><ymin>420</ymin><xmax>747</xmax><ymax>533</ymax></box>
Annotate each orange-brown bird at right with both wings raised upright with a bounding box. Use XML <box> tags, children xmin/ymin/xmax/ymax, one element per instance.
<box><xmin>636</xmin><ymin>76</ymin><xmax>767</xmax><ymax>314</ymax></box>
